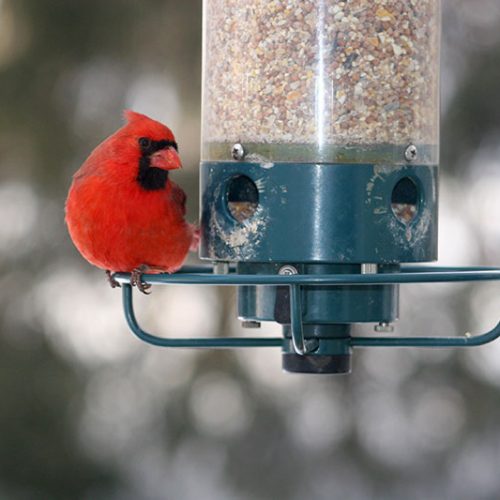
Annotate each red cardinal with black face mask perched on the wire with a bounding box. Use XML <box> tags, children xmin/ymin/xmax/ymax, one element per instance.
<box><xmin>66</xmin><ymin>111</ymin><xmax>199</xmax><ymax>293</ymax></box>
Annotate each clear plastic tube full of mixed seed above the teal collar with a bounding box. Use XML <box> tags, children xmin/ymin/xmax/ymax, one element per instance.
<box><xmin>202</xmin><ymin>0</ymin><xmax>440</xmax><ymax>164</ymax></box>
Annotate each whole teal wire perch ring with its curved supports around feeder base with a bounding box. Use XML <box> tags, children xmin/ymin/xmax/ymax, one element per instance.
<box><xmin>116</xmin><ymin>266</ymin><xmax>500</xmax><ymax>355</ymax></box>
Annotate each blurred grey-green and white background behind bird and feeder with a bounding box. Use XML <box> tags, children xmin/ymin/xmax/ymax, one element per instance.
<box><xmin>0</xmin><ymin>0</ymin><xmax>500</xmax><ymax>500</ymax></box>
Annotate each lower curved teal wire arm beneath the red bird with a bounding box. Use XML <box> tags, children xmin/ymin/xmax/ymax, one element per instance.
<box><xmin>122</xmin><ymin>284</ymin><xmax>284</xmax><ymax>349</ymax></box>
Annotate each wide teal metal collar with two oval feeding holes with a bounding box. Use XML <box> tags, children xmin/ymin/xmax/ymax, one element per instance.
<box><xmin>200</xmin><ymin>161</ymin><xmax>438</xmax><ymax>264</ymax></box>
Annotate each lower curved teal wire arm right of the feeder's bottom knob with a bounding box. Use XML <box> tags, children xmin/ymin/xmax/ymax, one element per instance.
<box><xmin>350</xmin><ymin>323</ymin><xmax>500</xmax><ymax>347</ymax></box>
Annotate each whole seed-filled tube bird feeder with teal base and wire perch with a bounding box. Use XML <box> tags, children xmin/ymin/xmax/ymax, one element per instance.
<box><xmin>121</xmin><ymin>0</ymin><xmax>500</xmax><ymax>373</ymax></box>
